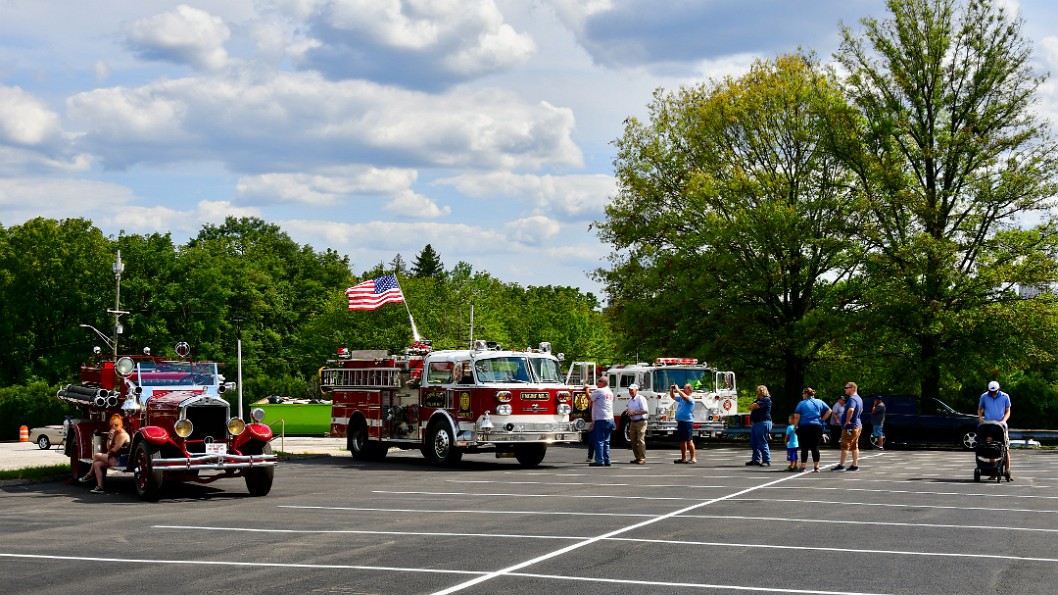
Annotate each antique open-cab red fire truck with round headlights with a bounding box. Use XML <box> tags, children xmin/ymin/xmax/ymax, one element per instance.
<box><xmin>58</xmin><ymin>343</ymin><xmax>276</xmax><ymax>502</ymax></box>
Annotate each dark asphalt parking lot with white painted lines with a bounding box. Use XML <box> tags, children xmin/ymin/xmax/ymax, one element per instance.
<box><xmin>0</xmin><ymin>438</ymin><xmax>1058</xmax><ymax>595</ymax></box>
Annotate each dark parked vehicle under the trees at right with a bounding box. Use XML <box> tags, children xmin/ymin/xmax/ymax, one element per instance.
<box><xmin>860</xmin><ymin>395</ymin><xmax>978</xmax><ymax>450</ymax></box>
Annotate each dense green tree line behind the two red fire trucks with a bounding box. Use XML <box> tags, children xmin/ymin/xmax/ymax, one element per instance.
<box><xmin>0</xmin><ymin>213</ymin><xmax>613</xmax><ymax>439</ymax></box>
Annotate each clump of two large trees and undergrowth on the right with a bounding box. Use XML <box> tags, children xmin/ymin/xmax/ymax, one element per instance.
<box><xmin>596</xmin><ymin>0</ymin><xmax>1058</xmax><ymax>427</ymax></box>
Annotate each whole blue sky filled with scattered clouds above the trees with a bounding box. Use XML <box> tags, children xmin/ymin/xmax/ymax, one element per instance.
<box><xmin>0</xmin><ymin>0</ymin><xmax>1058</xmax><ymax>295</ymax></box>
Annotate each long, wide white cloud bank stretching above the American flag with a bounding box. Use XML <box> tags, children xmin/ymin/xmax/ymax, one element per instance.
<box><xmin>67</xmin><ymin>73</ymin><xmax>583</xmax><ymax>173</ymax></box>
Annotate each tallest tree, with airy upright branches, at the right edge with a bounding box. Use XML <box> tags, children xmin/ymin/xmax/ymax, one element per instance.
<box><xmin>836</xmin><ymin>0</ymin><xmax>1058</xmax><ymax>396</ymax></box>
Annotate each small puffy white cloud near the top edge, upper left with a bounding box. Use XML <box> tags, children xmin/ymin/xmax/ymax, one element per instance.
<box><xmin>125</xmin><ymin>4</ymin><xmax>232</xmax><ymax>70</ymax></box>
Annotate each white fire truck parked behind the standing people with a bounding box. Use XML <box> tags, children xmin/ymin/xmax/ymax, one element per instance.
<box><xmin>606</xmin><ymin>358</ymin><xmax>738</xmax><ymax>444</ymax></box>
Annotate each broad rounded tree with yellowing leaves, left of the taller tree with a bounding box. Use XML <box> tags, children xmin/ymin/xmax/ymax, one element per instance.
<box><xmin>598</xmin><ymin>55</ymin><xmax>859</xmax><ymax>396</ymax></box>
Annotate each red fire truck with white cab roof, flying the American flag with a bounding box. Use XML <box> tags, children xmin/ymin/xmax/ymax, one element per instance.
<box><xmin>320</xmin><ymin>341</ymin><xmax>584</xmax><ymax>467</ymax></box>
